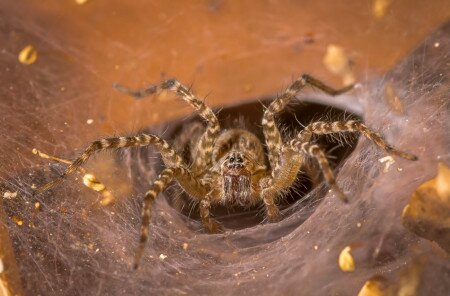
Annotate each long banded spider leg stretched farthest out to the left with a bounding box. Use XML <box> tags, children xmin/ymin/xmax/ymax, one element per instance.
<box><xmin>34</xmin><ymin>134</ymin><xmax>183</xmax><ymax>194</ymax></box>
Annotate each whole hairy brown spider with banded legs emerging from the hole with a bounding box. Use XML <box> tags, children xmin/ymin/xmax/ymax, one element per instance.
<box><xmin>36</xmin><ymin>75</ymin><xmax>417</xmax><ymax>268</ymax></box>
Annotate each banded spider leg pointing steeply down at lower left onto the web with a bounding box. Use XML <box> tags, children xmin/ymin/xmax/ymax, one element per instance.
<box><xmin>133</xmin><ymin>168</ymin><xmax>174</xmax><ymax>269</ymax></box>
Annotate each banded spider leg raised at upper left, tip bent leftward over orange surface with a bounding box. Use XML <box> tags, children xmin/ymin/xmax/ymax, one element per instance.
<box><xmin>113</xmin><ymin>79</ymin><xmax>220</xmax><ymax>171</ymax></box>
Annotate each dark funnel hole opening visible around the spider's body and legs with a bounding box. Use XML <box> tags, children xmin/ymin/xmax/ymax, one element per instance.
<box><xmin>128</xmin><ymin>99</ymin><xmax>361</xmax><ymax>229</ymax></box>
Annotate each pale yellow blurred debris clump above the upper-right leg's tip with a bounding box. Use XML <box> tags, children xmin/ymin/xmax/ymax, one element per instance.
<box><xmin>322</xmin><ymin>44</ymin><xmax>355</xmax><ymax>85</ymax></box>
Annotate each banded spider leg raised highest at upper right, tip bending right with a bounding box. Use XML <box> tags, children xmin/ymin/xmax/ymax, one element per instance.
<box><xmin>262</xmin><ymin>74</ymin><xmax>353</xmax><ymax>169</ymax></box>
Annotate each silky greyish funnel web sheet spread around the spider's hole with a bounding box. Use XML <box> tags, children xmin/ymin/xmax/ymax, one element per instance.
<box><xmin>0</xmin><ymin>2</ymin><xmax>450</xmax><ymax>295</ymax></box>
